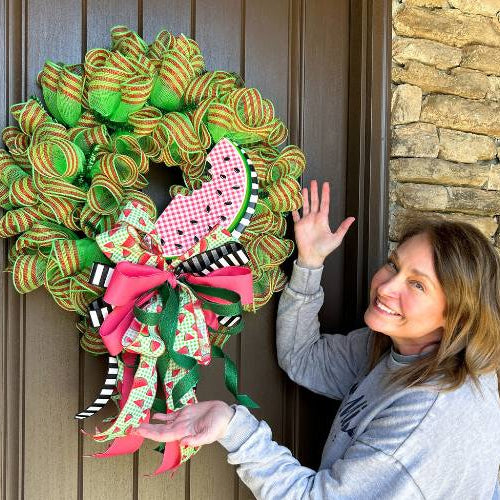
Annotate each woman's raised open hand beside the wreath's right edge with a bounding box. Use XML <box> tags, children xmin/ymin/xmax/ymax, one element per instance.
<box><xmin>292</xmin><ymin>180</ymin><xmax>355</xmax><ymax>267</ymax></box>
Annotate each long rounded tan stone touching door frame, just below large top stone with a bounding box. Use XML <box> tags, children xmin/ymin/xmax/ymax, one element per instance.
<box><xmin>392</xmin><ymin>37</ymin><xmax>462</xmax><ymax>69</ymax></box>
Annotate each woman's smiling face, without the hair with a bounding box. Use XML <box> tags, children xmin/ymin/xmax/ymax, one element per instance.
<box><xmin>365</xmin><ymin>234</ymin><xmax>446</xmax><ymax>354</ymax></box>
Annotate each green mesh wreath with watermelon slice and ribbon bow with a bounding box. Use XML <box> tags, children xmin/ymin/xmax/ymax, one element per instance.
<box><xmin>0</xmin><ymin>26</ymin><xmax>305</xmax><ymax>473</ymax></box>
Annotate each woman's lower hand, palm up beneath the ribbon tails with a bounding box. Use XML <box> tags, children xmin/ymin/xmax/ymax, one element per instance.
<box><xmin>132</xmin><ymin>401</ymin><xmax>234</xmax><ymax>446</ymax></box>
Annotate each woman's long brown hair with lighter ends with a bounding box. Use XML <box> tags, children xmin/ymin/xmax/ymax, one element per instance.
<box><xmin>370</xmin><ymin>219</ymin><xmax>500</xmax><ymax>390</ymax></box>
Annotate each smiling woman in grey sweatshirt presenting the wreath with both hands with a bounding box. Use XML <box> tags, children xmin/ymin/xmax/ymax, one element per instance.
<box><xmin>137</xmin><ymin>181</ymin><xmax>500</xmax><ymax>500</ymax></box>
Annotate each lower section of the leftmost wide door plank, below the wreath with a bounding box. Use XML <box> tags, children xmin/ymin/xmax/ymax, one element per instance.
<box><xmin>24</xmin><ymin>290</ymin><xmax>78</xmax><ymax>500</ymax></box>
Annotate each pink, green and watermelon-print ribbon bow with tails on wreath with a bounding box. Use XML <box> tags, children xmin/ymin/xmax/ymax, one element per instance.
<box><xmin>81</xmin><ymin>203</ymin><xmax>256</xmax><ymax>467</ymax></box>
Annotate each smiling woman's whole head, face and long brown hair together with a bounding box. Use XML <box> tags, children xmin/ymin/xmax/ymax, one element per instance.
<box><xmin>365</xmin><ymin>220</ymin><xmax>500</xmax><ymax>390</ymax></box>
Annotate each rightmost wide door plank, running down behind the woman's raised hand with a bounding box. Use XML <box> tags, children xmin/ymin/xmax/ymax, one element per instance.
<box><xmin>304</xmin><ymin>0</ymin><xmax>349</xmax><ymax>331</ymax></box>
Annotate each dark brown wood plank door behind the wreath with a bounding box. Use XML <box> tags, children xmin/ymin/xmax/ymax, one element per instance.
<box><xmin>0</xmin><ymin>0</ymin><xmax>389</xmax><ymax>500</ymax></box>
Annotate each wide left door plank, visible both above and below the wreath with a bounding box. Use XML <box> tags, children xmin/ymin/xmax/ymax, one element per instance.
<box><xmin>24</xmin><ymin>0</ymin><xmax>81</xmax><ymax>500</ymax></box>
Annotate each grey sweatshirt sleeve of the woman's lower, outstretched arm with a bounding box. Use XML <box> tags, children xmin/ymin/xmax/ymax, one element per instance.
<box><xmin>220</xmin><ymin>406</ymin><xmax>424</xmax><ymax>500</ymax></box>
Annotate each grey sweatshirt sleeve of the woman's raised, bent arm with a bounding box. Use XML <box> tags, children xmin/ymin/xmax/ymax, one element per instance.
<box><xmin>276</xmin><ymin>262</ymin><xmax>369</xmax><ymax>399</ymax></box>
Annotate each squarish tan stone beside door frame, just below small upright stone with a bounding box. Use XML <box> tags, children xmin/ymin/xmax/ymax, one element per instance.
<box><xmin>391</xmin><ymin>123</ymin><xmax>439</xmax><ymax>158</ymax></box>
